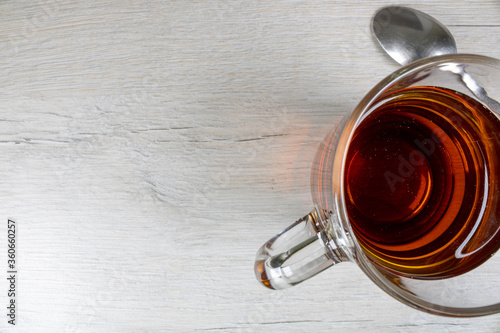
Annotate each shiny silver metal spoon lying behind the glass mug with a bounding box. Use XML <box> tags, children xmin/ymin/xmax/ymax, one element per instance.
<box><xmin>372</xmin><ymin>7</ymin><xmax>500</xmax><ymax>113</ymax></box>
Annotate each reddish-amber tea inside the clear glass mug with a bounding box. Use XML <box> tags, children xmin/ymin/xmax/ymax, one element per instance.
<box><xmin>344</xmin><ymin>87</ymin><xmax>500</xmax><ymax>279</ymax></box>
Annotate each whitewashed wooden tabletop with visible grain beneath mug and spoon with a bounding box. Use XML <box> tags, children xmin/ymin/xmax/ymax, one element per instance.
<box><xmin>0</xmin><ymin>0</ymin><xmax>500</xmax><ymax>332</ymax></box>
